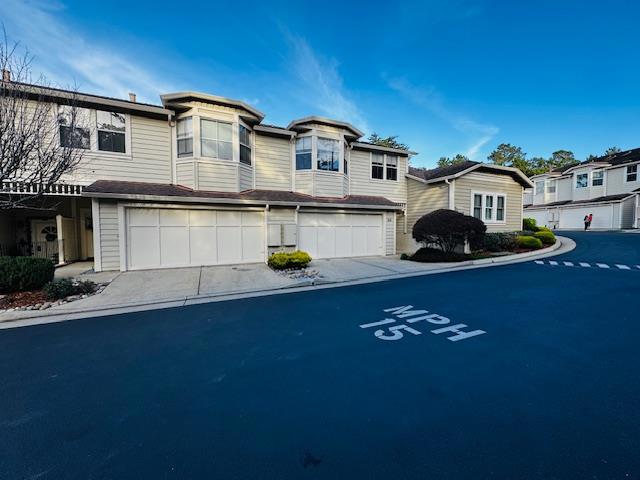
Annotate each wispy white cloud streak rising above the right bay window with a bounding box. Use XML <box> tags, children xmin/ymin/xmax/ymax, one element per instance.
<box><xmin>287</xmin><ymin>35</ymin><xmax>369</xmax><ymax>132</ymax></box>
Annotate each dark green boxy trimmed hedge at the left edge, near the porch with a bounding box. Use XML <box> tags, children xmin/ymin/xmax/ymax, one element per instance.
<box><xmin>0</xmin><ymin>257</ymin><xmax>55</xmax><ymax>293</ymax></box>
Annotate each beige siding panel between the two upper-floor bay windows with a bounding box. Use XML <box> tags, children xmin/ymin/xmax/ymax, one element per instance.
<box><xmin>255</xmin><ymin>135</ymin><xmax>291</xmax><ymax>191</ymax></box>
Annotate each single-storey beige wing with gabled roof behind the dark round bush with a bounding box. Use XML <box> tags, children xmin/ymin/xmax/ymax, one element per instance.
<box><xmin>398</xmin><ymin>161</ymin><xmax>532</xmax><ymax>251</ymax></box>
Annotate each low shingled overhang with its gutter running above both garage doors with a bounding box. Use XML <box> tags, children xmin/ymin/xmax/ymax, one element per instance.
<box><xmin>82</xmin><ymin>180</ymin><xmax>401</xmax><ymax>210</ymax></box>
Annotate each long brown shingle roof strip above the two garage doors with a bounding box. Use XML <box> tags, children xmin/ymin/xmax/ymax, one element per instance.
<box><xmin>84</xmin><ymin>180</ymin><xmax>399</xmax><ymax>207</ymax></box>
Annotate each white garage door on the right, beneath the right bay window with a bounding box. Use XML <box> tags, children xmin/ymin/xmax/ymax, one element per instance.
<box><xmin>298</xmin><ymin>213</ymin><xmax>384</xmax><ymax>258</ymax></box>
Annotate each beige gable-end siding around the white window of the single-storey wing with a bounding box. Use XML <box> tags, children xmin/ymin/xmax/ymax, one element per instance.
<box><xmin>454</xmin><ymin>172</ymin><xmax>523</xmax><ymax>232</ymax></box>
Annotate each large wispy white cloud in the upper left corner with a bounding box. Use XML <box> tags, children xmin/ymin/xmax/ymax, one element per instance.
<box><xmin>0</xmin><ymin>0</ymin><xmax>171</xmax><ymax>103</ymax></box>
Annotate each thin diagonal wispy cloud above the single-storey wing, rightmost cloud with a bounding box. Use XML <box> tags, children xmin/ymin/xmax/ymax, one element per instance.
<box><xmin>387</xmin><ymin>78</ymin><xmax>500</xmax><ymax>160</ymax></box>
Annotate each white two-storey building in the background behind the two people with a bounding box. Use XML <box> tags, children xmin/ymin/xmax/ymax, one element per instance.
<box><xmin>525</xmin><ymin>148</ymin><xmax>640</xmax><ymax>230</ymax></box>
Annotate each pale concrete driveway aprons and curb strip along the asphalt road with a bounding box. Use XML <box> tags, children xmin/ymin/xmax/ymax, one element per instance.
<box><xmin>0</xmin><ymin>237</ymin><xmax>575</xmax><ymax>329</ymax></box>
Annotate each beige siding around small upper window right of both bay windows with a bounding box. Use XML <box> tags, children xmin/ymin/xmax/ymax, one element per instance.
<box><xmin>349</xmin><ymin>150</ymin><xmax>407</xmax><ymax>203</ymax></box>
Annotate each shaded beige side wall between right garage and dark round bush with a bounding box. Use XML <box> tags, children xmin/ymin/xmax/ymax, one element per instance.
<box><xmin>396</xmin><ymin>178</ymin><xmax>449</xmax><ymax>253</ymax></box>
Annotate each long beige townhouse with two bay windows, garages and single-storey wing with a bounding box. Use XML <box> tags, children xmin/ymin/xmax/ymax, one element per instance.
<box><xmin>0</xmin><ymin>83</ymin><xmax>531</xmax><ymax>271</ymax></box>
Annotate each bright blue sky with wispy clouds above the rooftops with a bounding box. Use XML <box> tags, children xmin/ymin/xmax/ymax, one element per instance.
<box><xmin>0</xmin><ymin>0</ymin><xmax>640</xmax><ymax>166</ymax></box>
